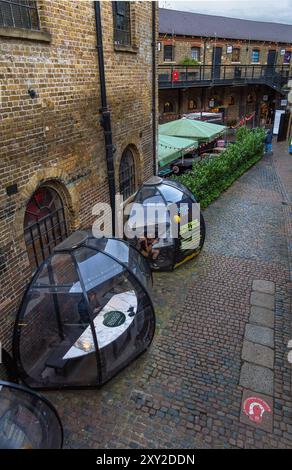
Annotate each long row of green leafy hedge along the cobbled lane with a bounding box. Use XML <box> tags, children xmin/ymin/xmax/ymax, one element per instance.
<box><xmin>173</xmin><ymin>128</ymin><xmax>265</xmax><ymax>209</ymax></box>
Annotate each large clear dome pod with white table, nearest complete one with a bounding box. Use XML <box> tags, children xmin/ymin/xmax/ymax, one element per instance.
<box><xmin>13</xmin><ymin>231</ymin><xmax>155</xmax><ymax>389</ymax></box>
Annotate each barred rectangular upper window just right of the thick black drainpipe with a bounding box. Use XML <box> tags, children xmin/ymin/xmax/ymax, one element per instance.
<box><xmin>113</xmin><ymin>2</ymin><xmax>131</xmax><ymax>46</ymax></box>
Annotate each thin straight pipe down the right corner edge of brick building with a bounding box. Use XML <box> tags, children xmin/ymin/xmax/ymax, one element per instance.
<box><xmin>152</xmin><ymin>2</ymin><xmax>158</xmax><ymax>175</ymax></box>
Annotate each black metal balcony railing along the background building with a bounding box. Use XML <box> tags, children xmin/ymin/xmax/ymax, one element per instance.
<box><xmin>158</xmin><ymin>64</ymin><xmax>291</xmax><ymax>90</ymax></box>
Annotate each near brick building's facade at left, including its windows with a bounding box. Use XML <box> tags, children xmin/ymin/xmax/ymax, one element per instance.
<box><xmin>0</xmin><ymin>0</ymin><xmax>157</xmax><ymax>349</ymax></box>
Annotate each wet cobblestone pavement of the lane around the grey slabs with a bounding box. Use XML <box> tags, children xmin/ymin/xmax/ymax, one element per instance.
<box><xmin>48</xmin><ymin>145</ymin><xmax>292</xmax><ymax>448</ymax></box>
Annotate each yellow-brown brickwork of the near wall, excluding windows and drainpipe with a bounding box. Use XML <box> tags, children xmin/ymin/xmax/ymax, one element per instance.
<box><xmin>0</xmin><ymin>0</ymin><xmax>157</xmax><ymax>349</ymax></box>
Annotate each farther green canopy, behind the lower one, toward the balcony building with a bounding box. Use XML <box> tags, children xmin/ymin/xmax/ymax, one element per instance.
<box><xmin>159</xmin><ymin>118</ymin><xmax>226</xmax><ymax>142</ymax></box>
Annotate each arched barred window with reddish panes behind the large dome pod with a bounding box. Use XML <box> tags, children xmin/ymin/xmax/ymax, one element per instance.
<box><xmin>24</xmin><ymin>186</ymin><xmax>68</xmax><ymax>268</ymax></box>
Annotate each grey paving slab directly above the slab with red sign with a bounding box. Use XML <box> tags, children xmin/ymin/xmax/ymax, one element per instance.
<box><xmin>239</xmin><ymin>362</ymin><xmax>274</xmax><ymax>396</ymax></box>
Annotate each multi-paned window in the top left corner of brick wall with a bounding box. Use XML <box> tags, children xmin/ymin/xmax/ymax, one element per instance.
<box><xmin>0</xmin><ymin>0</ymin><xmax>40</xmax><ymax>30</ymax></box>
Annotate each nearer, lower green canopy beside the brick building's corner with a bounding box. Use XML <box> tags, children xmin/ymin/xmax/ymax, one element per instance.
<box><xmin>158</xmin><ymin>134</ymin><xmax>198</xmax><ymax>166</ymax></box>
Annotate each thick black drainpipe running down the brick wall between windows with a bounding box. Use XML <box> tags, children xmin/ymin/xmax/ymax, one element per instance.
<box><xmin>93</xmin><ymin>2</ymin><xmax>116</xmax><ymax>235</ymax></box>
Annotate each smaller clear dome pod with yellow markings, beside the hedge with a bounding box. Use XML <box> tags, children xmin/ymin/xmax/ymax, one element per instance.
<box><xmin>126</xmin><ymin>176</ymin><xmax>206</xmax><ymax>271</ymax></box>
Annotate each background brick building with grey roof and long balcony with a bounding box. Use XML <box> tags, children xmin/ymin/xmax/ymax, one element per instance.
<box><xmin>158</xmin><ymin>9</ymin><xmax>292</xmax><ymax>124</ymax></box>
